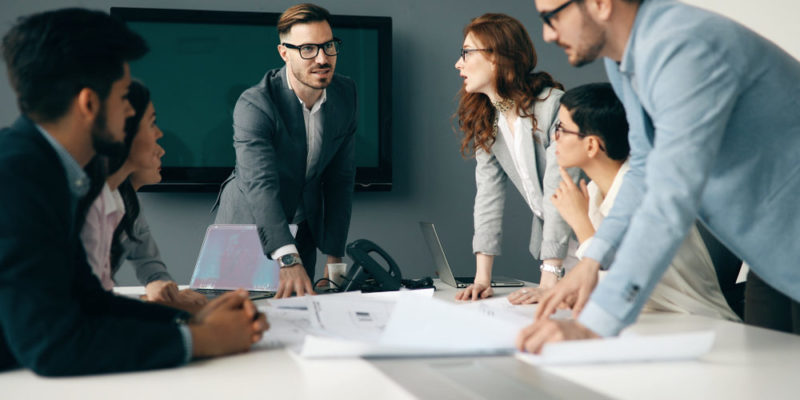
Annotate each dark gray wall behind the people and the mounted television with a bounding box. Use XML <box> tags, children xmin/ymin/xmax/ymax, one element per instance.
<box><xmin>0</xmin><ymin>0</ymin><xmax>606</xmax><ymax>285</ymax></box>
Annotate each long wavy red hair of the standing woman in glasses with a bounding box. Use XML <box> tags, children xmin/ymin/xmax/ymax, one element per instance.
<box><xmin>455</xmin><ymin>14</ymin><xmax>564</xmax><ymax>157</ymax></box>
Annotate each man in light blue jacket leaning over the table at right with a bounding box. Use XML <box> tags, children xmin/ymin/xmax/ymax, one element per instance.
<box><xmin>518</xmin><ymin>0</ymin><xmax>800</xmax><ymax>352</ymax></box>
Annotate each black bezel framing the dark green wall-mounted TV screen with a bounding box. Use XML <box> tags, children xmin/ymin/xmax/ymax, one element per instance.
<box><xmin>111</xmin><ymin>7</ymin><xmax>392</xmax><ymax>192</ymax></box>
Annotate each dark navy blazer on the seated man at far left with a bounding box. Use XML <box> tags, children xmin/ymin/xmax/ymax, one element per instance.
<box><xmin>0</xmin><ymin>117</ymin><xmax>186</xmax><ymax>376</ymax></box>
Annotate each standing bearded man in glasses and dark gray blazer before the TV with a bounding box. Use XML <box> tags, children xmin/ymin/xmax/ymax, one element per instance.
<box><xmin>216</xmin><ymin>4</ymin><xmax>356</xmax><ymax>297</ymax></box>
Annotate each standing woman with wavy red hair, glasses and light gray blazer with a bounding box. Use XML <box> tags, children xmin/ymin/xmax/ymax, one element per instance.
<box><xmin>455</xmin><ymin>14</ymin><xmax>579</xmax><ymax>304</ymax></box>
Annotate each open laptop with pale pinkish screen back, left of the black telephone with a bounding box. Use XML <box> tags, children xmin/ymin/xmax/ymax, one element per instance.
<box><xmin>189</xmin><ymin>224</ymin><xmax>280</xmax><ymax>299</ymax></box>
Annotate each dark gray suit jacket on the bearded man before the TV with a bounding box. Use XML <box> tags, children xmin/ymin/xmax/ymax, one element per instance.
<box><xmin>216</xmin><ymin>66</ymin><xmax>356</xmax><ymax>256</ymax></box>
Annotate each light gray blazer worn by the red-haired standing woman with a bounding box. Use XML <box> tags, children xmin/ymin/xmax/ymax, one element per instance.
<box><xmin>472</xmin><ymin>89</ymin><xmax>580</xmax><ymax>260</ymax></box>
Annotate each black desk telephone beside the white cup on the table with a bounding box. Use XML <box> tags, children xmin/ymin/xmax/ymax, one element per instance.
<box><xmin>342</xmin><ymin>239</ymin><xmax>403</xmax><ymax>292</ymax></box>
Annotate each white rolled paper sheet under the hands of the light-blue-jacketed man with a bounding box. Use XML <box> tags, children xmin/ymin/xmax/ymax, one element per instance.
<box><xmin>517</xmin><ymin>331</ymin><xmax>715</xmax><ymax>366</ymax></box>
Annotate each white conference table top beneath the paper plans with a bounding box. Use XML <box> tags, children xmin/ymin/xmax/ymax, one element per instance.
<box><xmin>0</xmin><ymin>282</ymin><xmax>800</xmax><ymax>400</ymax></box>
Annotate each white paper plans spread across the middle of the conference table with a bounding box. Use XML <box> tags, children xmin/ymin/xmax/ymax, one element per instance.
<box><xmin>261</xmin><ymin>290</ymin><xmax>714</xmax><ymax>365</ymax></box>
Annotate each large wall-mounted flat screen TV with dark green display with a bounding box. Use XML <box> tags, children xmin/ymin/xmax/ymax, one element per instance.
<box><xmin>111</xmin><ymin>7</ymin><xmax>392</xmax><ymax>191</ymax></box>
